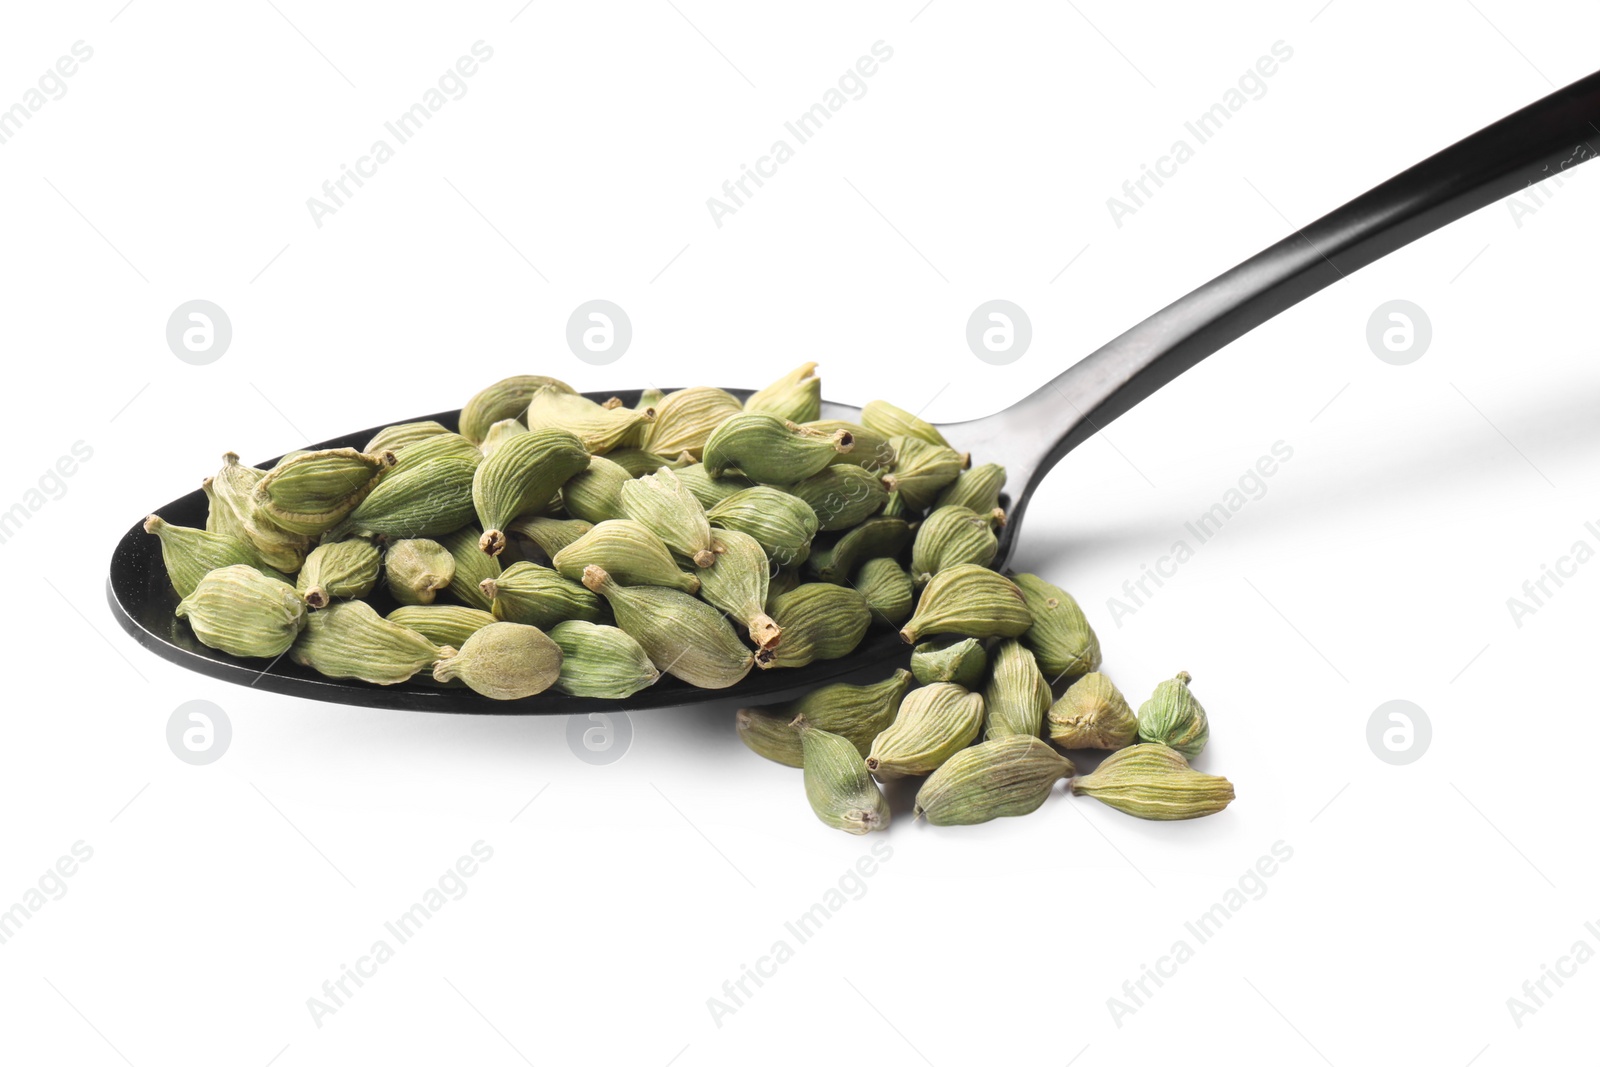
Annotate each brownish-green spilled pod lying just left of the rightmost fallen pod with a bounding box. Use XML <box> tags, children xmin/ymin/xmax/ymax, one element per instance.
<box><xmin>915</xmin><ymin>734</ymin><xmax>1075</xmax><ymax>825</ymax></box>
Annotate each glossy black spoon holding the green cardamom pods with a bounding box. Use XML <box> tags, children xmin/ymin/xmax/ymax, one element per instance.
<box><xmin>107</xmin><ymin>74</ymin><xmax>1600</xmax><ymax>715</ymax></box>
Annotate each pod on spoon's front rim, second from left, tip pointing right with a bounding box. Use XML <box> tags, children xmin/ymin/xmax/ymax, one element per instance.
<box><xmin>290</xmin><ymin>600</ymin><xmax>453</xmax><ymax>685</ymax></box>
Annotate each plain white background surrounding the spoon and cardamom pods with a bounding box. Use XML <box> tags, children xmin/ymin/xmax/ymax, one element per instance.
<box><xmin>0</xmin><ymin>0</ymin><xmax>1600</xmax><ymax>1067</ymax></box>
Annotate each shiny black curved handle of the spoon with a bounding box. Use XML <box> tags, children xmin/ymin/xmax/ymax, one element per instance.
<box><xmin>958</xmin><ymin>72</ymin><xmax>1600</xmax><ymax>553</ymax></box>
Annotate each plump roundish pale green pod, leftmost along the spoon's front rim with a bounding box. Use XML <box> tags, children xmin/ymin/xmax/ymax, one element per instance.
<box><xmin>178</xmin><ymin>563</ymin><xmax>306</xmax><ymax>659</ymax></box>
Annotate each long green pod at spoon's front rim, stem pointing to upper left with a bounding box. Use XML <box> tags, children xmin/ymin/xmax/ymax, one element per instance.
<box><xmin>584</xmin><ymin>563</ymin><xmax>755</xmax><ymax>689</ymax></box>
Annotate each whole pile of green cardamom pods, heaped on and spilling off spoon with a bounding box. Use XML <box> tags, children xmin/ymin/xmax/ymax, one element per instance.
<box><xmin>144</xmin><ymin>363</ymin><xmax>1232</xmax><ymax>833</ymax></box>
